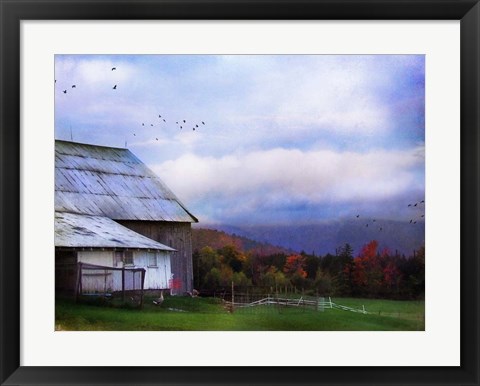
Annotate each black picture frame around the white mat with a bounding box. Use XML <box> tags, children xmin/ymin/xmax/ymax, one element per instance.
<box><xmin>0</xmin><ymin>0</ymin><xmax>480</xmax><ymax>385</ymax></box>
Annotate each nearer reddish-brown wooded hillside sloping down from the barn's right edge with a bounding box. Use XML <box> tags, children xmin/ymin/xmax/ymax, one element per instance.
<box><xmin>192</xmin><ymin>227</ymin><xmax>295</xmax><ymax>256</ymax></box>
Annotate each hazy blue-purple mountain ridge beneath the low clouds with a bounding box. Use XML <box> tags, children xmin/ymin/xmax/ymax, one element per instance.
<box><xmin>201</xmin><ymin>219</ymin><xmax>425</xmax><ymax>256</ymax></box>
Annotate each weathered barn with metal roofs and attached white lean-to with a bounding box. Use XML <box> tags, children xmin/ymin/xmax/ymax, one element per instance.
<box><xmin>55</xmin><ymin>140</ymin><xmax>198</xmax><ymax>294</ymax></box>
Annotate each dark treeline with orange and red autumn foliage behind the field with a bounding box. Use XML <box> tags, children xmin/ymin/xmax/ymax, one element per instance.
<box><xmin>193</xmin><ymin>240</ymin><xmax>425</xmax><ymax>299</ymax></box>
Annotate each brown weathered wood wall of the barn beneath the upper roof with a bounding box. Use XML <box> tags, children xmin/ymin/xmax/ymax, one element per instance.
<box><xmin>117</xmin><ymin>220</ymin><xmax>193</xmax><ymax>294</ymax></box>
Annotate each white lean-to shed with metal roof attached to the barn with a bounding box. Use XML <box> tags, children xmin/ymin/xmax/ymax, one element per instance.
<box><xmin>55</xmin><ymin>212</ymin><xmax>175</xmax><ymax>293</ymax></box>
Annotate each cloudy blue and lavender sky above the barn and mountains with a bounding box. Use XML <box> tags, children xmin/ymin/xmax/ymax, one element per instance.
<box><xmin>55</xmin><ymin>55</ymin><xmax>425</xmax><ymax>225</ymax></box>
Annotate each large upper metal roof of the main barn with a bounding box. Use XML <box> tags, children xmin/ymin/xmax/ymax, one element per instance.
<box><xmin>55</xmin><ymin>140</ymin><xmax>198</xmax><ymax>222</ymax></box>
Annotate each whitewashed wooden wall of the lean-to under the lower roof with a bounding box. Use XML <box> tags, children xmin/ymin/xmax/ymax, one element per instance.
<box><xmin>78</xmin><ymin>251</ymin><xmax>171</xmax><ymax>293</ymax></box>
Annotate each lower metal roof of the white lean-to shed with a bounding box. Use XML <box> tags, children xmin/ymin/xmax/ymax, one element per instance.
<box><xmin>55</xmin><ymin>212</ymin><xmax>175</xmax><ymax>251</ymax></box>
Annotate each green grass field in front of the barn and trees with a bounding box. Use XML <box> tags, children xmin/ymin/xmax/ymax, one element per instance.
<box><xmin>55</xmin><ymin>297</ymin><xmax>425</xmax><ymax>331</ymax></box>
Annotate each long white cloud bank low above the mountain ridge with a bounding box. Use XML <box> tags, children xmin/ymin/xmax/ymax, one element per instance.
<box><xmin>153</xmin><ymin>148</ymin><xmax>424</xmax><ymax>208</ymax></box>
